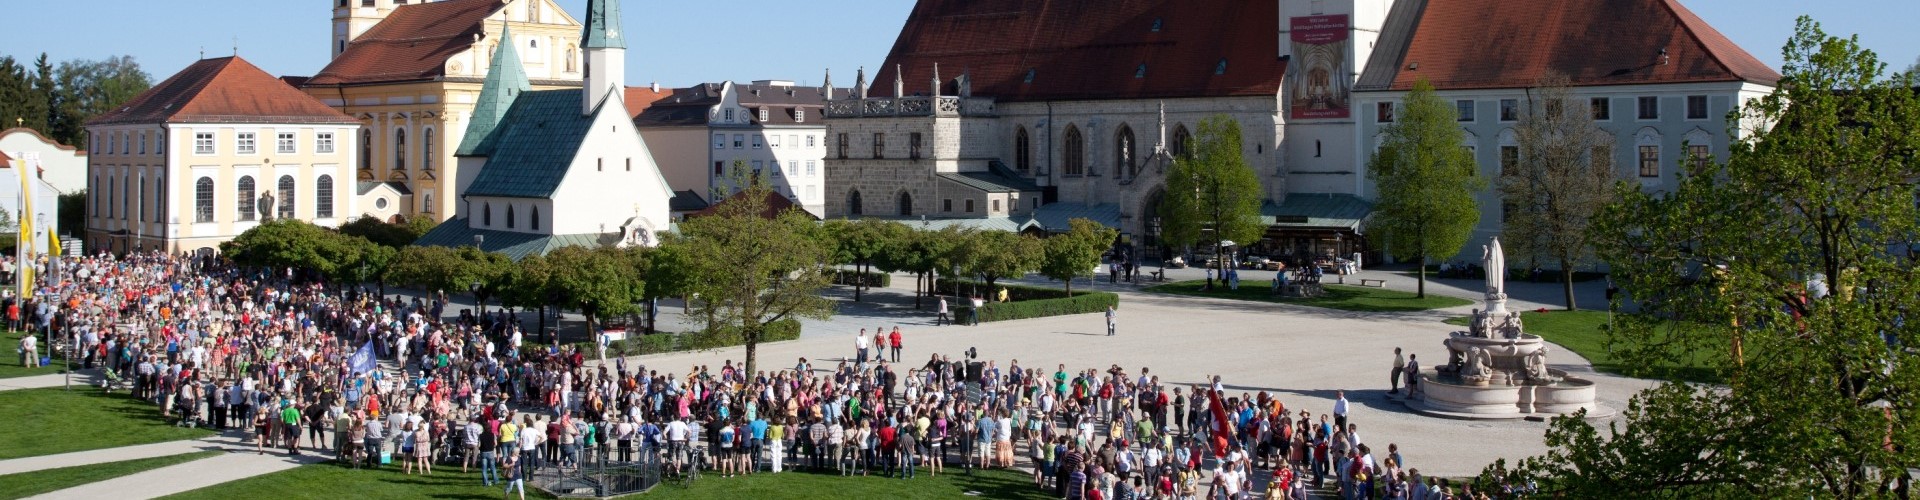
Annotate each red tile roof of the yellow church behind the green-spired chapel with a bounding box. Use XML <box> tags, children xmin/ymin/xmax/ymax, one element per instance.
<box><xmin>307</xmin><ymin>0</ymin><xmax>505</xmax><ymax>85</ymax></box>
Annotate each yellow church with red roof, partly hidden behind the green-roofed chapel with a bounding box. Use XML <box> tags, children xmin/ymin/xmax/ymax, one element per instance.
<box><xmin>290</xmin><ymin>0</ymin><xmax>582</xmax><ymax>221</ymax></box>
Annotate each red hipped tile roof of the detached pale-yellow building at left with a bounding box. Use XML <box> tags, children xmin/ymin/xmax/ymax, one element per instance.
<box><xmin>86</xmin><ymin>56</ymin><xmax>359</xmax><ymax>125</ymax></box>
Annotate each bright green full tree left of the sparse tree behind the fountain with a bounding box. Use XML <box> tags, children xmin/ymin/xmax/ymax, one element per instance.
<box><xmin>1367</xmin><ymin>79</ymin><xmax>1482</xmax><ymax>298</ymax></box>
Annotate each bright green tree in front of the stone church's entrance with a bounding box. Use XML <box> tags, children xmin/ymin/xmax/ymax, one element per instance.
<box><xmin>1160</xmin><ymin>115</ymin><xmax>1267</xmax><ymax>288</ymax></box>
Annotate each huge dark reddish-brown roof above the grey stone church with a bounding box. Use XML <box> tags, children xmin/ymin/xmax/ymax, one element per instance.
<box><xmin>868</xmin><ymin>0</ymin><xmax>1286</xmax><ymax>102</ymax></box>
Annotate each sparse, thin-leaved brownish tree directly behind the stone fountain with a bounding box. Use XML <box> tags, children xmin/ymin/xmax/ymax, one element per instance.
<box><xmin>1488</xmin><ymin>75</ymin><xmax>1619</xmax><ymax>312</ymax></box>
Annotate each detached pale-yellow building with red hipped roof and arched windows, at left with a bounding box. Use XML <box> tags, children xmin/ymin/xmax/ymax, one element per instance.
<box><xmin>86</xmin><ymin>58</ymin><xmax>361</xmax><ymax>254</ymax></box>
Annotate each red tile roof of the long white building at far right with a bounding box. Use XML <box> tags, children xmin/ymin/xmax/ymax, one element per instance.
<box><xmin>1369</xmin><ymin>0</ymin><xmax>1780</xmax><ymax>90</ymax></box>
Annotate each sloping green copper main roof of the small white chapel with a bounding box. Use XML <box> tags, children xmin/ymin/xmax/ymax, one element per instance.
<box><xmin>465</xmin><ymin>88</ymin><xmax>591</xmax><ymax>198</ymax></box>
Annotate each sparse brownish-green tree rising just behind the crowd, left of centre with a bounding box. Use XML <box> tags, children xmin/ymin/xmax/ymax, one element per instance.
<box><xmin>662</xmin><ymin>183</ymin><xmax>833</xmax><ymax>373</ymax></box>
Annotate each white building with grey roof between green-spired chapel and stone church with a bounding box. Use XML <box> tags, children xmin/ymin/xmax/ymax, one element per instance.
<box><xmin>626</xmin><ymin>79</ymin><xmax>849</xmax><ymax>217</ymax></box>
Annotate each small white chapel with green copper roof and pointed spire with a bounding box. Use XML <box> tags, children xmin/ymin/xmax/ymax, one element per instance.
<box><xmin>417</xmin><ymin>0</ymin><xmax>674</xmax><ymax>260</ymax></box>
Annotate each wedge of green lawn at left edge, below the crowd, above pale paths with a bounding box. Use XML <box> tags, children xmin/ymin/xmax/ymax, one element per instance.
<box><xmin>0</xmin><ymin>385</ymin><xmax>213</xmax><ymax>460</ymax></box>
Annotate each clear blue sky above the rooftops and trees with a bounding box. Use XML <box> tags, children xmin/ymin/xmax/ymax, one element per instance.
<box><xmin>0</xmin><ymin>0</ymin><xmax>1920</xmax><ymax>87</ymax></box>
